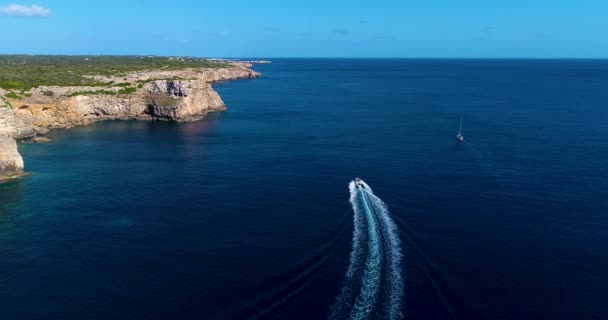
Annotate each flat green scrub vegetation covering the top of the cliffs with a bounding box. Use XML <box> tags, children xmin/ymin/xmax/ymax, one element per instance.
<box><xmin>0</xmin><ymin>55</ymin><xmax>226</xmax><ymax>90</ymax></box>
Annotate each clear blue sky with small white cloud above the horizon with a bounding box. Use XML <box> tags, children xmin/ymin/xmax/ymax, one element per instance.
<box><xmin>0</xmin><ymin>0</ymin><xmax>608</xmax><ymax>58</ymax></box>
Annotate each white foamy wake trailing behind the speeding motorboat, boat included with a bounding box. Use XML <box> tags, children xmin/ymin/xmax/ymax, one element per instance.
<box><xmin>329</xmin><ymin>181</ymin><xmax>404</xmax><ymax>320</ymax></box>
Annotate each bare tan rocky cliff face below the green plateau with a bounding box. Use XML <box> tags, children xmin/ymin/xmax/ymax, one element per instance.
<box><xmin>0</xmin><ymin>62</ymin><xmax>260</xmax><ymax>181</ymax></box>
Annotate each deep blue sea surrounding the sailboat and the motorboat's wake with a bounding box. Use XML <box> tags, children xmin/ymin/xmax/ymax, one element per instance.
<box><xmin>0</xmin><ymin>59</ymin><xmax>608</xmax><ymax>319</ymax></box>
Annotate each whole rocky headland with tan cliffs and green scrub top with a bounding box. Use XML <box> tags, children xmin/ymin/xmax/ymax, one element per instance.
<box><xmin>0</xmin><ymin>55</ymin><xmax>262</xmax><ymax>180</ymax></box>
